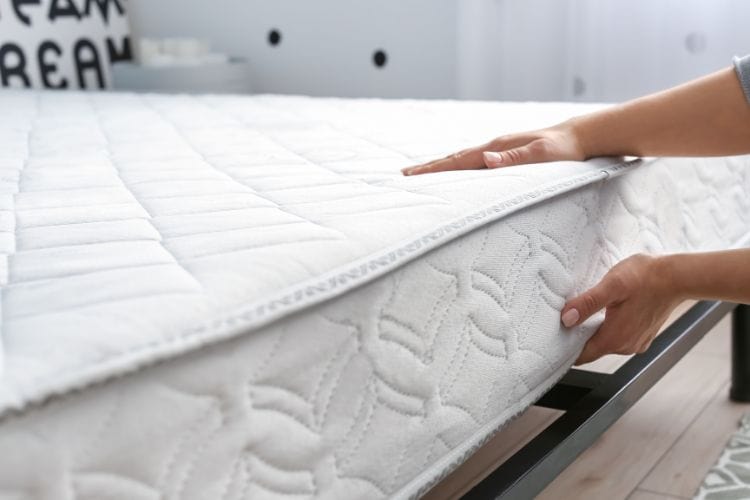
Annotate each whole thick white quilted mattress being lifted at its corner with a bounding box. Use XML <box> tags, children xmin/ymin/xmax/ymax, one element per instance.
<box><xmin>0</xmin><ymin>91</ymin><xmax>750</xmax><ymax>499</ymax></box>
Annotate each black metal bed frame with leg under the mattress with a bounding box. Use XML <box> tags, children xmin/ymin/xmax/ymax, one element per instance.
<box><xmin>464</xmin><ymin>301</ymin><xmax>750</xmax><ymax>500</ymax></box>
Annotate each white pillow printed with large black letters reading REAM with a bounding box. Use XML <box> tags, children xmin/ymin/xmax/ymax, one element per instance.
<box><xmin>0</xmin><ymin>0</ymin><xmax>131</xmax><ymax>89</ymax></box>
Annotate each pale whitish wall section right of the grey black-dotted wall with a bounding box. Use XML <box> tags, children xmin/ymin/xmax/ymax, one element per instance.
<box><xmin>459</xmin><ymin>0</ymin><xmax>750</xmax><ymax>101</ymax></box>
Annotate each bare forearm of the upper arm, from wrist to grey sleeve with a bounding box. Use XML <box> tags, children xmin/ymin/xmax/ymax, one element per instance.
<box><xmin>569</xmin><ymin>68</ymin><xmax>750</xmax><ymax>158</ymax></box>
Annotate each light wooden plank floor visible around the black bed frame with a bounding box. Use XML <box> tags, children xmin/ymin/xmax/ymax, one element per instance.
<box><xmin>427</xmin><ymin>306</ymin><xmax>750</xmax><ymax>500</ymax></box>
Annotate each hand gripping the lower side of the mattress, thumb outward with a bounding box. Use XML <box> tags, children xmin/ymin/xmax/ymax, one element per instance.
<box><xmin>562</xmin><ymin>255</ymin><xmax>683</xmax><ymax>365</ymax></box>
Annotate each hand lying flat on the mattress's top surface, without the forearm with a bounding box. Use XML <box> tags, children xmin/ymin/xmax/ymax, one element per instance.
<box><xmin>402</xmin><ymin>120</ymin><xmax>586</xmax><ymax>175</ymax></box>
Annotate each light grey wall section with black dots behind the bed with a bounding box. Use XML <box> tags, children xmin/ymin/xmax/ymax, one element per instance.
<box><xmin>129</xmin><ymin>0</ymin><xmax>456</xmax><ymax>97</ymax></box>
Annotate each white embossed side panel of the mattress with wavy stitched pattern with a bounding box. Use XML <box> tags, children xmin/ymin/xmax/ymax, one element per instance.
<box><xmin>0</xmin><ymin>159</ymin><xmax>750</xmax><ymax>498</ymax></box>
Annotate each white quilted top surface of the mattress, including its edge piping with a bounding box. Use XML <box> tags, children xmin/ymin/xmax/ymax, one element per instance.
<box><xmin>0</xmin><ymin>91</ymin><xmax>638</xmax><ymax>414</ymax></box>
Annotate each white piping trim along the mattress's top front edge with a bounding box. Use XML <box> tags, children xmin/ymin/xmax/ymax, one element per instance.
<box><xmin>0</xmin><ymin>159</ymin><xmax>644</xmax><ymax>417</ymax></box>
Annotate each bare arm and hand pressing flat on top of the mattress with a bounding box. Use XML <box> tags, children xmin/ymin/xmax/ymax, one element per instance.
<box><xmin>403</xmin><ymin>68</ymin><xmax>750</xmax><ymax>175</ymax></box>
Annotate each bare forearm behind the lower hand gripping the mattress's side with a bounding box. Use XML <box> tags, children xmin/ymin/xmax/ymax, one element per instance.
<box><xmin>658</xmin><ymin>248</ymin><xmax>750</xmax><ymax>304</ymax></box>
